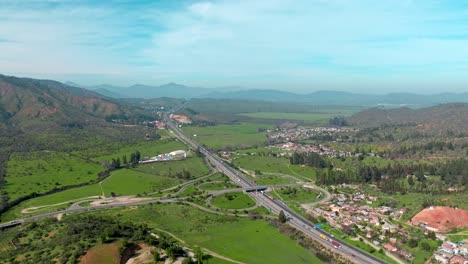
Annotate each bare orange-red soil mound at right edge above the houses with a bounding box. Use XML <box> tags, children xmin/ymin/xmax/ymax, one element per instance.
<box><xmin>411</xmin><ymin>206</ymin><xmax>468</xmax><ymax>232</ymax></box>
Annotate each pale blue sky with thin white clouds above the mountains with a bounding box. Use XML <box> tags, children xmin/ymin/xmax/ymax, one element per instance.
<box><xmin>0</xmin><ymin>0</ymin><xmax>468</xmax><ymax>93</ymax></box>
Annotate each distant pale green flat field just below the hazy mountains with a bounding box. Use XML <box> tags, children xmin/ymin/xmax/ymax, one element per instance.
<box><xmin>239</xmin><ymin>112</ymin><xmax>342</xmax><ymax>125</ymax></box>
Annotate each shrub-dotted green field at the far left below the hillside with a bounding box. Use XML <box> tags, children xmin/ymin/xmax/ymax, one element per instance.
<box><xmin>4</xmin><ymin>151</ymin><xmax>104</xmax><ymax>200</ymax></box>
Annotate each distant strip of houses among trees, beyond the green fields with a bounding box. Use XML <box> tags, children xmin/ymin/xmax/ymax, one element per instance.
<box><xmin>268</xmin><ymin>127</ymin><xmax>357</xmax><ymax>142</ymax></box>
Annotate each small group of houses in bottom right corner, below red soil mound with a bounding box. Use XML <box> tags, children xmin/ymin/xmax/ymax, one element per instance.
<box><xmin>432</xmin><ymin>241</ymin><xmax>468</xmax><ymax>264</ymax></box>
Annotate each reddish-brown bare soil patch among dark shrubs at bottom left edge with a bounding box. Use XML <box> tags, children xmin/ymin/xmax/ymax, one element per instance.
<box><xmin>81</xmin><ymin>242</ymin><xmax>121</xmax><ymax>264</ymax></box>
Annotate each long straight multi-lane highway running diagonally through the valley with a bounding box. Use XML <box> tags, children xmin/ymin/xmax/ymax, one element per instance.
<box><xmin>165</xmin><ymin>116</ymin><xmax>386</xmax><ymax>264</ymax></box>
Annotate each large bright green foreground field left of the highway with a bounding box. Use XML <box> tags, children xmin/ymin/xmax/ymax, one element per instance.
<box><xmin>93</xmin><ymin>204</ymin><xmax>321</xmax><ymax>264</ymax></box>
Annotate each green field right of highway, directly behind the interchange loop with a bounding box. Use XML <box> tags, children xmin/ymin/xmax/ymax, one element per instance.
<box><xmin>234</xmin><ymin>156</ymin><xmax>316</xmax><ymax>181</ymax></box>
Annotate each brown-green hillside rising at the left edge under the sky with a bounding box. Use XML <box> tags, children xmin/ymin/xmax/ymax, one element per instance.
<box><xmin>0</xmin><ymin>75</ymin><xmax>130</xmax><ymax>125</ymax></box>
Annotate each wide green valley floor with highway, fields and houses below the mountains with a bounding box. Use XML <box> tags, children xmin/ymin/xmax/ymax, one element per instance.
<box><xmin>0</xmin><ymin>75</ymin><xmax>468</xmax><ymax>263</ymax></box>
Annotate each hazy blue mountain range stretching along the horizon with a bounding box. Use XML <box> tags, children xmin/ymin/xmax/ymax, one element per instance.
<box><xmin>68</xmin><ymin>83</ymin><xmax>468</xmax><ymax>107</ymax></box>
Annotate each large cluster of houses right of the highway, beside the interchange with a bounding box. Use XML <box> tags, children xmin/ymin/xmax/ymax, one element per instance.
<box><xmin>312</xmin><ymin>192</ymin><xmax>414</xmax><ymax>261</ymax></box>
